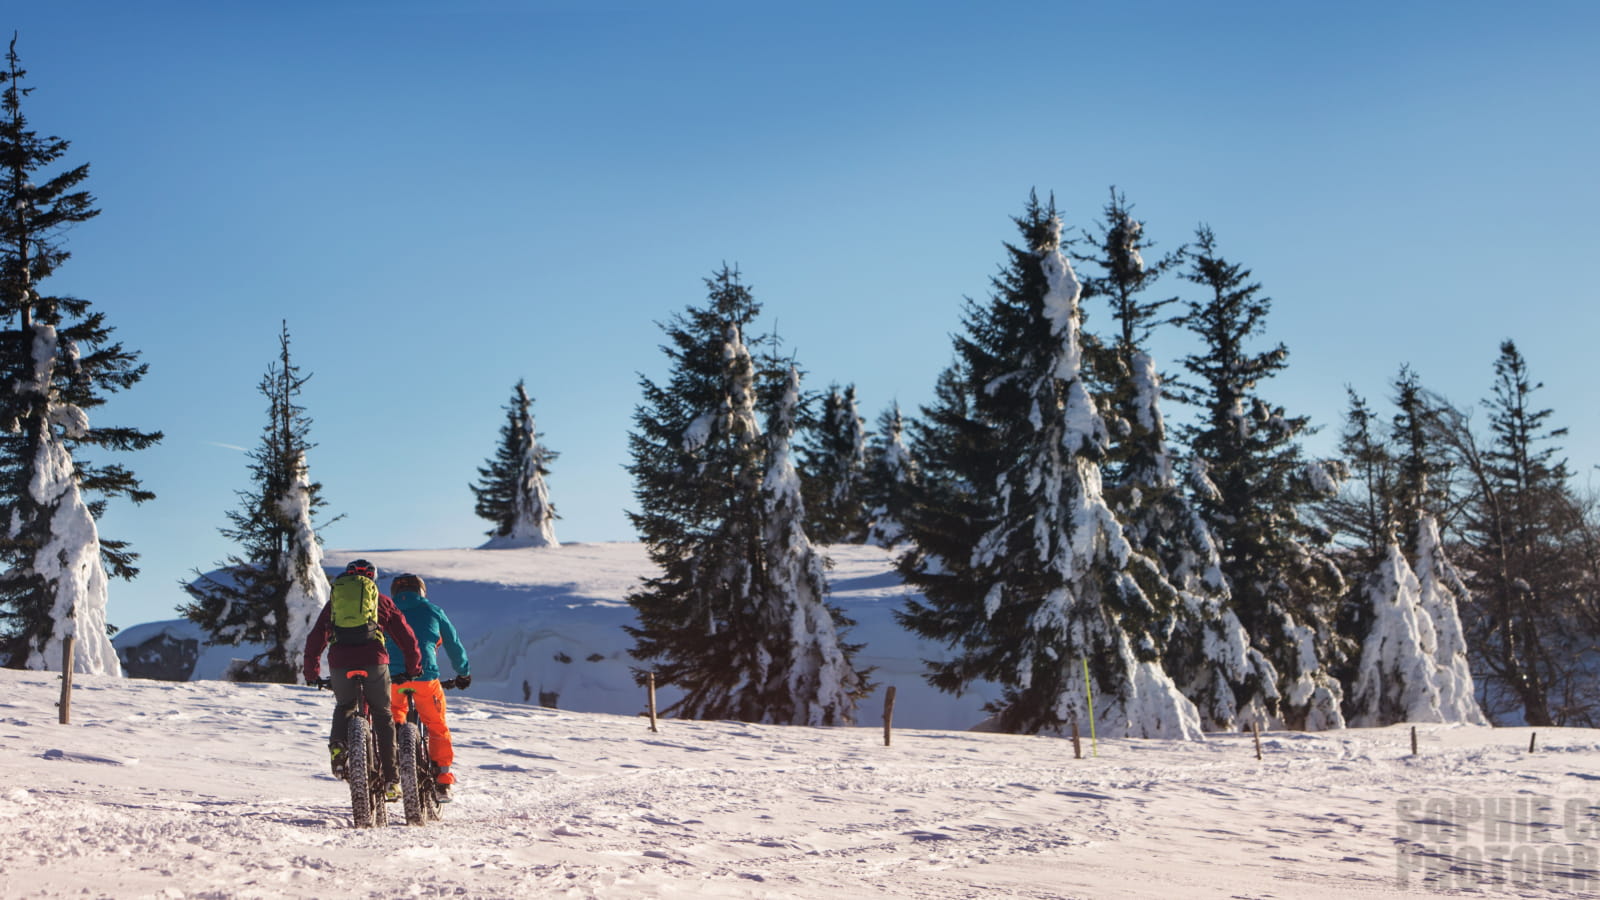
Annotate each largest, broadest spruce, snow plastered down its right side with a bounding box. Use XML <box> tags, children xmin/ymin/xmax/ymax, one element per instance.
<box><xmin>901</xmin><ymin>197</ymin><xmax>1200</xmax><ymax>738</ymax></box>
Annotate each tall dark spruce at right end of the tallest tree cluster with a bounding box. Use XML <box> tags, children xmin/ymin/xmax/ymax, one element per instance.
<box><xmin>1179</xmin><ymin>227</ymin><xmax>1344</xmax><ymax>730</ymax></box>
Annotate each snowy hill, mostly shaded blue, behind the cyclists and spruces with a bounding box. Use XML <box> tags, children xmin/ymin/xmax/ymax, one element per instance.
<box><xmin>115</xmin><ymin>543</ymin><xmax>997</xmax><ymax>729</ymax></box>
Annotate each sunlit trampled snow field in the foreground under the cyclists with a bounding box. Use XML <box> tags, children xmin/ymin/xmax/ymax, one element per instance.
<box><xmin>0</xmin><ymin>671</ymin><xmax>1600</xmax><ymax>900</ymax></box>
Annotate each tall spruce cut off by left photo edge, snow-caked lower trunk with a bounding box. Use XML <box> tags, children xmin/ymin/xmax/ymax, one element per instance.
<box><xmin>0</xmin><ymin>37</ymin><xmax>162</xmax><ymax>674</ymax></box>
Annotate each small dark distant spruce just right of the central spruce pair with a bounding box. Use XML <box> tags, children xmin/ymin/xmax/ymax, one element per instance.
<box><xmin>800</xmin><ymin>384</ymin><xmax>867</xmax><ymax>544</ymax></box>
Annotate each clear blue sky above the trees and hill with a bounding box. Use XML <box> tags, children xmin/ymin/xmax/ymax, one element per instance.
<box><xmin>0</xmin><ymin>0</ymin><xmax>1600</xmax><ymax>626</ymax></box>
